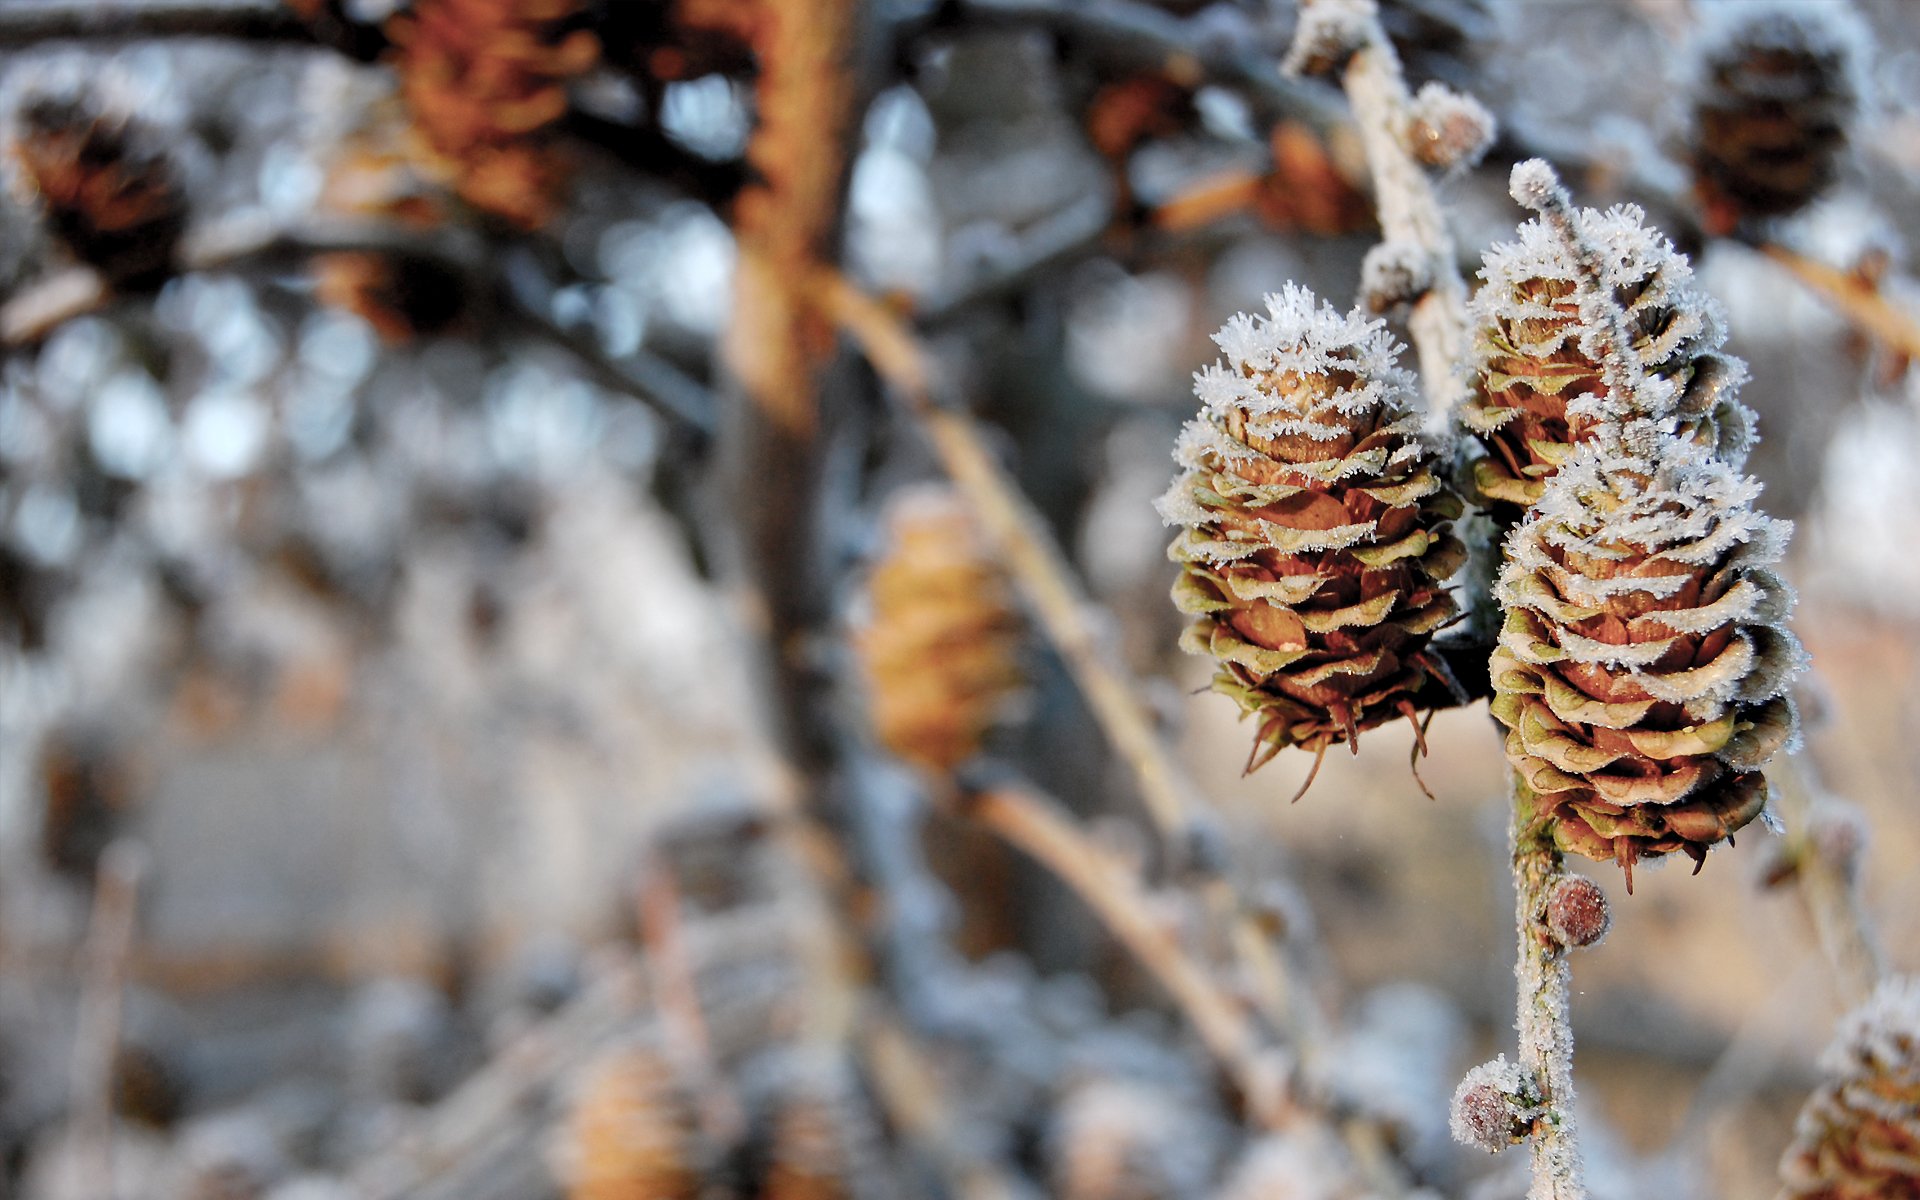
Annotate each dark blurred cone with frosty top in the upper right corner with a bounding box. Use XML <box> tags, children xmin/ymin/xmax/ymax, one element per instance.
<box><xmin>1692</xmin><ymin>2</ymin><xmax>1864</xmax><ymax>234</ymax></box>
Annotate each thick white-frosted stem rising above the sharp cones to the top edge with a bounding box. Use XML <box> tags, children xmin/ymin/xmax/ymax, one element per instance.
<box><xmin>1344</xmin><ymin>10</ymin><xmax>1467</xmax><ymax>422</ymax></box>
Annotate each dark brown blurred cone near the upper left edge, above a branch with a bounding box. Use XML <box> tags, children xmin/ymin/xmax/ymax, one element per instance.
<box><xmin>13</xmin><ymin>96</ymin><xmax>186</xmax><ymax>290</ymax></box>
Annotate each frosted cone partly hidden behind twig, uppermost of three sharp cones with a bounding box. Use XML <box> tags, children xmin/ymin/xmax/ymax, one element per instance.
<box><xmin>1461</xmin><ymin>205</ymin><xmax>1753</xmax><ymax>526</ymax></box>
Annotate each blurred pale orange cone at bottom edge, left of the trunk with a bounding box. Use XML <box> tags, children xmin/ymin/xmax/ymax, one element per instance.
<box><xmin>564</xmin><ymin>1048</ymin><xmax>707</xmax><ymax>1200</ymax></box>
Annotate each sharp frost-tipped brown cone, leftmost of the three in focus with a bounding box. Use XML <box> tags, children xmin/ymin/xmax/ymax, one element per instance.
<box><xmin>1160</xmin><ymin>284</ymin><xmax>1465</xmax><ymax>783</ymax></box>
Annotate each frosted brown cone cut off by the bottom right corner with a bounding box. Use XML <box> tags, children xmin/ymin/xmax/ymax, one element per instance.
<box><xmin>1780</xmin><ymin>975</ymin><xmax>1920</xmax><ymax>1200</ymax></box>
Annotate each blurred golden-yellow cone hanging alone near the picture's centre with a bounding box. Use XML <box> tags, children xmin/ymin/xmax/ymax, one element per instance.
<box><xmin>856</xmin><ymin>488</ymin><xmax>1021</xmax><ymax>772</ymax></box>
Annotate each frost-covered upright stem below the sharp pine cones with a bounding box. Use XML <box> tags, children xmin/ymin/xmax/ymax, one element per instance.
<box><xmin>1511</xmin><ymin>772</ymin><xmax>1586</xmax><ymax>1200</ymax></box>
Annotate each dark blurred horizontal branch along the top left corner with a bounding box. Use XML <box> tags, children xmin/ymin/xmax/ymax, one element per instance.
<box><xmin>0</xmin><ymin>0</ymin><xmax>299</xmax><ymax>50</ymax></box>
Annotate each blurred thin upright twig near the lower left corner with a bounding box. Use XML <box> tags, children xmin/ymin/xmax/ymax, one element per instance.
<box><xmin>67</xmin><ymin>841</ymin><xmax>146</xmax><ymax>1196</ymax></box>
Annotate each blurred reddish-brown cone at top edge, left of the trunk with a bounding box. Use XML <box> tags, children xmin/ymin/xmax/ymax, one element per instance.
<box><xmin>388</xmin><ymin>0</ymin><xmax>599</xmax><ymax>228</ymax></box>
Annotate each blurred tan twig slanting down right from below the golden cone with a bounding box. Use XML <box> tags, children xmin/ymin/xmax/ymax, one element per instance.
<box><xmin>966</xmin><ymin>787</ymin><xmax>1298</xmax><ymax>1125</ymax></box>
